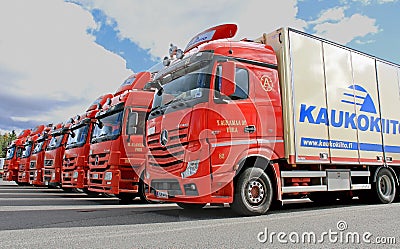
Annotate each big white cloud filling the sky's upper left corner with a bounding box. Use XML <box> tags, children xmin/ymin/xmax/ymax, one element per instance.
<box><xmin>0</xmin><ymin>0</ymin><xmax>131</xmax><ymax>127</ymax></box>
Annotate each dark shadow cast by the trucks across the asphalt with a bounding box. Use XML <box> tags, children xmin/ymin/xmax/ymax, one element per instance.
<box><xmin>0</xmin><ymin>182</ymin><xmax>388</xmax><ymax>230</ymax></box>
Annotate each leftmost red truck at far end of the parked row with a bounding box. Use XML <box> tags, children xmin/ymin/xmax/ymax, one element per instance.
<box><xmin>3</xmin><ymin>129</ymin><xmax>31</xmax><ymax>183</ymax></box>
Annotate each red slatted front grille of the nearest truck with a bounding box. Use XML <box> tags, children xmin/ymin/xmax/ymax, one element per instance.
<box><xmin>148</xmin><ymin>127</ymin><xmax>188</xmax><ymax>171</ymax></box>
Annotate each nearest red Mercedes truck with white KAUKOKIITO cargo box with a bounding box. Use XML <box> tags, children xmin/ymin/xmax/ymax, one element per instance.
<box><xmin>145</xmin><ymin>24</ymin><xmax>400</xmax><ymax>215</ymax></box>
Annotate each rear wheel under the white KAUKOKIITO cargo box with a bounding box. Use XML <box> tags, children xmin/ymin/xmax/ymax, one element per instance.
<box><xmin>373</xmin><ymin>168</ymin><xmax>396</xmax><ymax>204</ymax></box>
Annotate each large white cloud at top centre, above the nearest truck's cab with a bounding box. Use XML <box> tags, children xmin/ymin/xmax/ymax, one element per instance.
<box><xmin>71</xmin><ymin>0</ymin><xmax>306</xmax><ymax>57</ymax></box>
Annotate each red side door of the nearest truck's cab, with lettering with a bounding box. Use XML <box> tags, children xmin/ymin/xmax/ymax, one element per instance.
<box><xmin>207</xmin><ymin>62</ymin><xmax>257</xmax><ymax>181</ymax></box>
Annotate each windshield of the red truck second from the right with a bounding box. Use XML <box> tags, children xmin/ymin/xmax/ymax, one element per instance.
<box><xmin>91</xmin><ymin>110</ymin><xmax>122</xmax><ymax>143</ymax></box>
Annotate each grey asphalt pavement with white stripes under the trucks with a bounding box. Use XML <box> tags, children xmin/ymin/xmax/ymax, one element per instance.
<box><xmin>0</xmin><ymin>180</ymin><xmax>400</xmax><ymax>249</ymax></box>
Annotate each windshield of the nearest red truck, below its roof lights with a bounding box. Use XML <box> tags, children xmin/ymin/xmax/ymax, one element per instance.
<box><xmin>153</xmin><ymin>68</ymin><xmax>210</xmax><ymax>109</ymax></box>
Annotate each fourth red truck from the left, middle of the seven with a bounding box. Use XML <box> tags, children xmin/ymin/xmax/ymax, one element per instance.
<box><xmin>43</xmin><ymin>123</ymin><xmax>70</xmax><ymax>188</ymax></box>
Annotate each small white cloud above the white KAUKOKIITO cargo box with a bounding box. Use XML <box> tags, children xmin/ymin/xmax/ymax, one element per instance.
<box><xmin>310</xmin><ymin>7</ymin><xmax>379</xmax><ymax>44</ymax></box>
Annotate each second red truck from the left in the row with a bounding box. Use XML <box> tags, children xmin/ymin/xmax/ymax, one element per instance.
<box><xmin>18</xmin><ymin>125</ymin><xmax>46</xmax><ymax>185</ymax></box>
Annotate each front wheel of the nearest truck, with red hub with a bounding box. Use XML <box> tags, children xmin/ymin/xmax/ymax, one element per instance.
<box><xmin>231</xmin><ymin>168</ymin><xmax>273</xmax><ymax>215</ymax></box>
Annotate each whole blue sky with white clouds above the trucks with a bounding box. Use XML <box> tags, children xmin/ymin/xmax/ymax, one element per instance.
<box><xmin>0</xmin><ymin>0</ymin><xmax>400</xmax><ymax>132</ymax></box>
